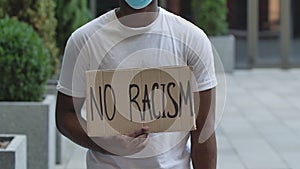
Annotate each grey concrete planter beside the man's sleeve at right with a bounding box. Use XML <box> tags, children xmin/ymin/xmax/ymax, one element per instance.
<box><xmin>209</xmin><ymin>35</ymin><xmax>235</xmax><ymax>73</ymax></box>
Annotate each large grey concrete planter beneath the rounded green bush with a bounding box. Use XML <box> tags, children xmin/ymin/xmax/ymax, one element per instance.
<box><xmin>0</xmin><ymin>95</ymin><xmax>56</xmax><ymax>169</ymax></box>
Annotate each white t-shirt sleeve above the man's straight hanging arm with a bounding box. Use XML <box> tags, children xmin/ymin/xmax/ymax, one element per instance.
<box><xmin>187</xmin><ymin>28</ymin><xmax>217</xmax><ymax>92</ymax></box>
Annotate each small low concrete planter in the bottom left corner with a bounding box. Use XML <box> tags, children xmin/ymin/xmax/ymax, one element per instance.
<box><xmin>0</xmin><ymin>135</ymin><xmax>27</xmax><ymax>169</ymax></box>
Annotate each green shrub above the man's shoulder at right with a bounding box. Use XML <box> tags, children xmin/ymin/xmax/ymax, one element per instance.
<box><xmin>192</xmin><ymin>0</ymin><xmax>228</xmax><ymax>36</ymax></box>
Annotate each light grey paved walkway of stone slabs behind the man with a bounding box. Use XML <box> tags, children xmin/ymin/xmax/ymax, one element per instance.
<box><xmin>56</xmin><ymin>69</ymin><xmax>300</xmax><ymax>169</ymax></box>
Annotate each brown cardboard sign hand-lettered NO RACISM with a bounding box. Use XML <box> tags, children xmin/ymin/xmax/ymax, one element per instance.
<box><xmin>86</xmin><ymin>66</ymin><xmax>196</xmax><ymax>137</ymax></box>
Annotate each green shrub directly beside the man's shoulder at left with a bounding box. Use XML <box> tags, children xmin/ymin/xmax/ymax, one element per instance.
<box><xmin>56</xmin><ymin>0</ymin><xmax>92</xmax><ymax>55</ymax></box>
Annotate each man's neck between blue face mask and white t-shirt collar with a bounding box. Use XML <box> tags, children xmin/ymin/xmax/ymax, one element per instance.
<box><xmin>116</xmin><ymin>0</ymin><xmax>158</xmax><ymax>27</ymax></box>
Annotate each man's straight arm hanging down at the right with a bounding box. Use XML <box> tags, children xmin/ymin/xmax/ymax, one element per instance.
<box><xmin>191</xmin><ymin>88</ymin><xmax>217</xmax><ymax>169</ymax></box>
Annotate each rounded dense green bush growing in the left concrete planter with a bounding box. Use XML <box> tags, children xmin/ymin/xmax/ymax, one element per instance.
<box><xmin>0</xmin><ymin>18</ymin><xmax>51</xmax><ymax>101</ymax></box>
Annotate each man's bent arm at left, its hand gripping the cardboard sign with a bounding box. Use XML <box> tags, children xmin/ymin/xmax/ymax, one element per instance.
<box><xmin>56</xmin><ymin>92</ymin><xmax>149</xmax><ymax>155</ymax></box>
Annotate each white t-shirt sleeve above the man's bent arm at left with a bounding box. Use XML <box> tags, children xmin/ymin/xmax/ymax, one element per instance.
<box><xmin>56</xmin><ymin>34</ymin><xmax>89</xmax><ymax>98</ymax></box>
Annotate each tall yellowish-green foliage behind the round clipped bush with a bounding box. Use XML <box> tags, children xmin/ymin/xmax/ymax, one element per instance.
<box><xmin>0</xmin><ymin>0</ymin><xmax>59</xmax><ymax>74</ymax></box>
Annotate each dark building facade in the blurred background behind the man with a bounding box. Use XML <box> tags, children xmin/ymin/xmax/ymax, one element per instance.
<box><xmin>90</xmin><ymin>0</ymin><xmax>300</xmax><ymax>68</ymax></box>
